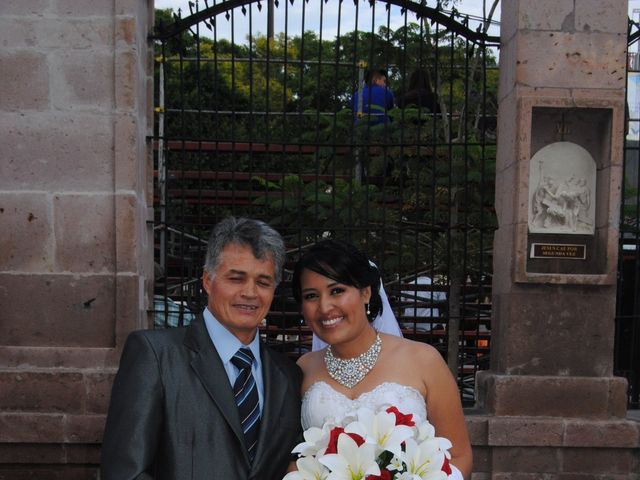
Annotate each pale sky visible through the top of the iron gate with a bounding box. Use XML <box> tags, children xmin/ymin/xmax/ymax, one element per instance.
<box><xmin>155</xmin><ymin>0</ymin><xmax>504</xmax><ymax>43</ymax></box>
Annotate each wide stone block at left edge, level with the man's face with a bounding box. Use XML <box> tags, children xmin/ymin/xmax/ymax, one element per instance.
<box><xmin>0</xmin><ymin>274</ymin><xmax>115</xmax><ymax>348</ymax></box>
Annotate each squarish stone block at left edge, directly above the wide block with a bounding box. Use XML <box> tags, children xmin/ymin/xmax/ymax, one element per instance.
<box><xmin>0</xmin><ymin>192</ymin><xmax>55</xmax><ymax>273</ymax></box>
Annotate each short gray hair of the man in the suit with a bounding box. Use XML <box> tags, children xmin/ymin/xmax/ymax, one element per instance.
<box><xmin>204</xmin><ymin>217</ymin><xmax>286</xmax><ymax>283</ymax></box>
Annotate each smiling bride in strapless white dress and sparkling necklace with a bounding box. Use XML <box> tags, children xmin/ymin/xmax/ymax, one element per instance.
<box><xmin>292</xmin><ymin>240</ymin><xmax>472</xmax><ymax>480</ymax></box>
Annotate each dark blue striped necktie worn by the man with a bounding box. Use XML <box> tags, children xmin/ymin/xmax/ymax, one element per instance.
<box><xmin>231</xmin><ymin>348</ymin><xmax>260</xmax><ymax>461</ymax></box>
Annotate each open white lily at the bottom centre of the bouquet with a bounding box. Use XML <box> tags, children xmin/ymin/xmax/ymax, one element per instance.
<box><xmin>318</xmin><ymin>433</ymin><xmax>380</xmax><ymax>480</ymax></box>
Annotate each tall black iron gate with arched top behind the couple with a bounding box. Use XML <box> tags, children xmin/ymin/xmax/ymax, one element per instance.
<box><xmin>153</xmin><ymin>0</ymin><xmax>499</xmax><ymax>405</ymax></box>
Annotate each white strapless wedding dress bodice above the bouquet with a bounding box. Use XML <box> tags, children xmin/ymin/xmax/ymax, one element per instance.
<box><xmin>302</xmin><ymin>381</ymin><xmax>427</xmax><ymax>430</ymax></box>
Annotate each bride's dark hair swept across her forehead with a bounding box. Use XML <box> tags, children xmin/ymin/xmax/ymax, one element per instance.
<box><xmin>291</xmin><ymin>240</ymin><xmax>382</xmax><ymax>322</ymax></box>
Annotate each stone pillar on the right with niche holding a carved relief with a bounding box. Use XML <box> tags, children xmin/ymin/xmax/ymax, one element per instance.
<box><xmin>472</xmin><ymin>0</ymin><xmax>640</xmax><ymax>479</ymax></box>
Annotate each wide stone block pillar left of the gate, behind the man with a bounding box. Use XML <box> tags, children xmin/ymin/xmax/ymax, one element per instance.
<box><xmin>0</xmin><ymin>0</ymin><xmax>153</xmax><ymax>479</ymax></box>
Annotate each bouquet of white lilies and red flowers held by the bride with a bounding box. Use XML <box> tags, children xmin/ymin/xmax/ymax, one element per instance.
<box><xmin>283</xmin><ymin>406</ymin><xmax>451</xmax><ymax>480</ymax></box>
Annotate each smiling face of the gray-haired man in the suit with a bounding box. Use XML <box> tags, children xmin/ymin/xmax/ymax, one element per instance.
<box><xmin>202</xmin><ymin>244</ymin><xmax>276</xmax><ymax>345</ymax></box>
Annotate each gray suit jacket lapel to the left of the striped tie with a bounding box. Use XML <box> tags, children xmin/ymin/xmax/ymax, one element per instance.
<box><xmin>184</xmin><ymin>317</ymin><xmax>249</xmax><ymax>463</ymax></box>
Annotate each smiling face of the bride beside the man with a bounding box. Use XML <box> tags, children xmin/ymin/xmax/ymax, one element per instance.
<box><xmin>300</xmin><ymin>270</ymin><xmax>371</xmax><ymax>345</ymax></box>
